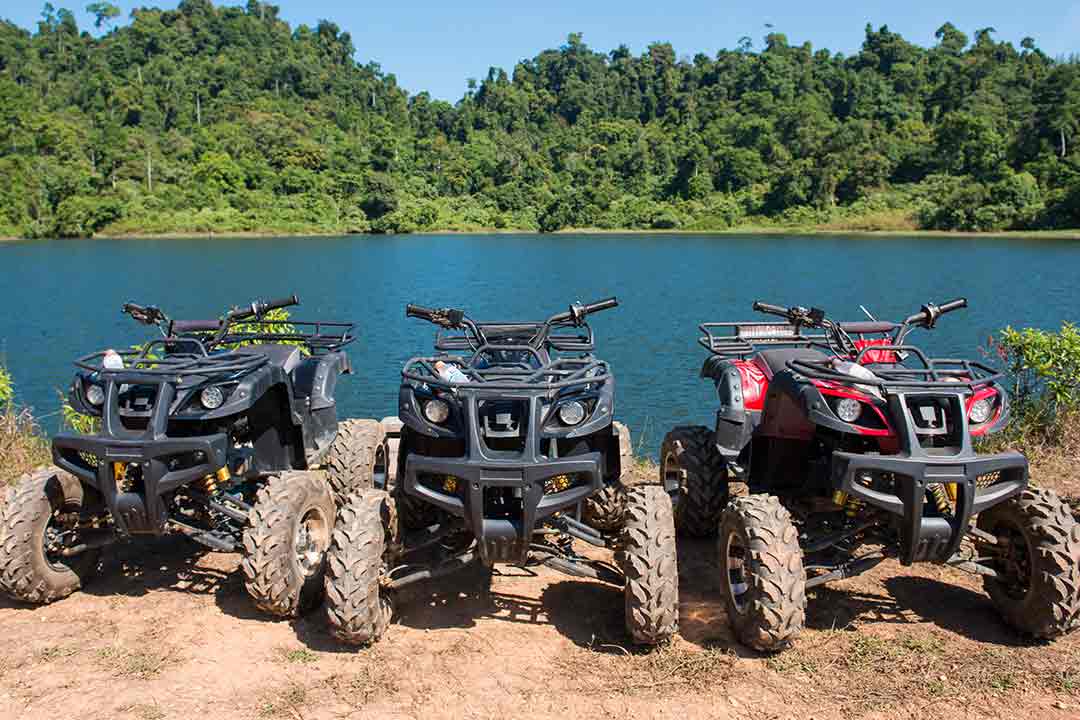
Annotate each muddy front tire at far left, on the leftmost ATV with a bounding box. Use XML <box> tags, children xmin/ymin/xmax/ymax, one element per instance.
<box><xmin>0</xmin><ymin>467</ymin><xmax>100</xmax><ymax>604</ymax></box>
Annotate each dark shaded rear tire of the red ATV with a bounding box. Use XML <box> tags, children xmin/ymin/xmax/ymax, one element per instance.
<box><xmin>660</xmin><ymin>425</ymin><xmax>729</xmax><ymax>538</ymax></box>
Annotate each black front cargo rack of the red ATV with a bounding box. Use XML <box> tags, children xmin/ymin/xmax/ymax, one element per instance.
<box><xmin>787</xmin><ymin>344</ymin><xmax>1004</xmax><ymax>390</ymax></box>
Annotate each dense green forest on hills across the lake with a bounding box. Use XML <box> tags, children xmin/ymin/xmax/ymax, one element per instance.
<box><xmin>0</xmin><ymin>0</ymin><xmax>1080</xmax><ymax>237</ymax></box>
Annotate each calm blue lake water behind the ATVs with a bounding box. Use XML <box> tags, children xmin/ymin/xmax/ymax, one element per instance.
<box><xmin>0</xmin><ymin>234</ymin><xmax>1080</xmax><ymax>453</ymax></box>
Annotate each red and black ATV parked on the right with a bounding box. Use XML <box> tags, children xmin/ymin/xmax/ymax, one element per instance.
<box><xmin>661</xmin><ymin>299</ymin><xmax>1080</xmax><ymax>650</ymax></box>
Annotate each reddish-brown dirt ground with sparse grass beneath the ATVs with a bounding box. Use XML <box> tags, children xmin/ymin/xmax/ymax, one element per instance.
<box><xmin>0</xmin><ymin>470</ymin><xmax>1080</xmax><ymax>720</ymax></box>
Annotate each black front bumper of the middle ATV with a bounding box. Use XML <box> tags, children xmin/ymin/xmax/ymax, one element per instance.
<box><xmin>404</xmin><ymin>452</ymin><xmax>604</xmax><ymax>563</ymax></box>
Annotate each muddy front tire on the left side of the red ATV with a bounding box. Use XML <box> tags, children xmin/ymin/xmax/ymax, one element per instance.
<box><xmin>718</xmin><ymin>495</ymin><xmax>807</xmax><ymax>652</ymax></box>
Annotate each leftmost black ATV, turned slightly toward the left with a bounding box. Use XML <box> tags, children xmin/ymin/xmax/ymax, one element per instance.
<box><xmin>0</xmin><ymin>296</ymin><xmax>382</xmax><ymax>616</ymax></box>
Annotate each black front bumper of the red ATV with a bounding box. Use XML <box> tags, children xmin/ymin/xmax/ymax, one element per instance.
<box><xmin>832</xmin><ymin>452</ymin><xmax>1027</xmax><ymax>565</ymax></box>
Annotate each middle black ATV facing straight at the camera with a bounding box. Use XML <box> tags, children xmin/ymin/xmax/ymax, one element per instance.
<box><xmin>326</xmin><ymin>298</ymin><xmax>678</xmax><ymax>644</ymax></box>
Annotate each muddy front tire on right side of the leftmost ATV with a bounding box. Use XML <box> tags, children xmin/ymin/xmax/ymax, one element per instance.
<box><xmin>241</xmin><ymin>471</ymin><xmax>336</xmax><ymax>617</ymax></box>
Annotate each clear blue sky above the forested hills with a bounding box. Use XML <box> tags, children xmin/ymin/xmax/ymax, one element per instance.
<box><xmin>0</xmin><ymin>0</ymin><xmax>1080</xmax><ymax>100</ymax></box>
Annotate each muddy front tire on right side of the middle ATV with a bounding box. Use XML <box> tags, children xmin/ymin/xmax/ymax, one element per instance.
<box><xmin>616</xmin><ymin>485</ymin><xmax>678</xmax><ymax>646</ymax></box>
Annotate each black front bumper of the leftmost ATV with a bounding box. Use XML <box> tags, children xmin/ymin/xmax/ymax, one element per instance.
<box><xmin>53</xmin><ymin>433</ymin><xmax>228</xmax><ymax>535</ymax></box>
